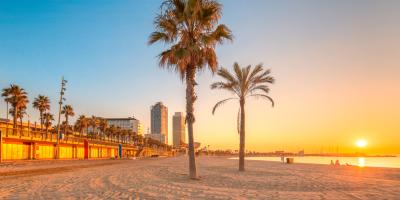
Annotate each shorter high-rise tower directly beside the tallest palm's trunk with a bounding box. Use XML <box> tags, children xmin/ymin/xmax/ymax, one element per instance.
<box><xmin>172</xmin><ymin>112</ymin><xmax>186</xmax><ymax>147</ymax></box>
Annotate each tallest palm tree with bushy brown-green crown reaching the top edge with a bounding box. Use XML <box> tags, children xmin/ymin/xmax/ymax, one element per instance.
<box><xmin>149</xmin><ymin>0</ymin><xmax>232</xmax><ymax>179</ymax></box>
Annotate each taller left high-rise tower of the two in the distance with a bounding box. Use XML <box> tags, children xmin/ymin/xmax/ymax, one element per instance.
<box><xmin>151</xmin><ymin>102</ymin><xmax>168</xmax><ymax>144</ymax></box>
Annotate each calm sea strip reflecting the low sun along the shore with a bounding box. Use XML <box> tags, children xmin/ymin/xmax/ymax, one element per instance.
<box><xmin>233</xmin><ymin>156</ymin><xmax>400</xmax><ymax>168</ymax></box>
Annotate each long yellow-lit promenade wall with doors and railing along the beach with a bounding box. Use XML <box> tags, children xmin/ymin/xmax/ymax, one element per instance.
<box><xmin>0</xmin><ymin>118</ymin><xmax>172</xmax><ymax>162</ymax></box>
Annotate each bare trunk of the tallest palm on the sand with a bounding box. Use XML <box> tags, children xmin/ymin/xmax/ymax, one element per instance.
<box><xmin>186</xmin><ymin>66</ymin><xmax>197</xmax><ymax>179</ymax></box>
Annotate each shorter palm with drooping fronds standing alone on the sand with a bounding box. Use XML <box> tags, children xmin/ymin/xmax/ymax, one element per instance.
<box><xmin>211</xmin><ymin>63</ymin><xmax>275</xmax><ymax>171</ymax></box>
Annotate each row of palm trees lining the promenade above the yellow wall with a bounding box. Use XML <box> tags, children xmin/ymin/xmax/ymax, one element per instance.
<box><xmin>2</xmin><ymin>84</ymin><xmax>143</xmax><ymax>143</ymax></box>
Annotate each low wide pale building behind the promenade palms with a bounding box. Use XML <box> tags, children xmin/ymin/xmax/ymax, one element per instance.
<box><xmin>106</xmin><ymin>117</ymin><xmax>143</xmax><ymax>135</ymax></box>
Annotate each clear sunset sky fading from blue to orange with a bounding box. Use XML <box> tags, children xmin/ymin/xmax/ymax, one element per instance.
<box><xmin>0</xmin><ymin>0</ymin><xmax>400</xmax><ymax>154</ymax></box>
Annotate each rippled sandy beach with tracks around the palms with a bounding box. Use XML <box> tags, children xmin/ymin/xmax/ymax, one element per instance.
<box><xmin>0</xmin><ymin>157</ymin><xmax>400</xmax><ymax>199</ymax></box>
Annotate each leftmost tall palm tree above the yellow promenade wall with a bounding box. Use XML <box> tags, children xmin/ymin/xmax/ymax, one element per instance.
<box><xmin>1</xmin><ymin>84</ymin><xmax>29</xmax><ymax>129</ymax></box>
